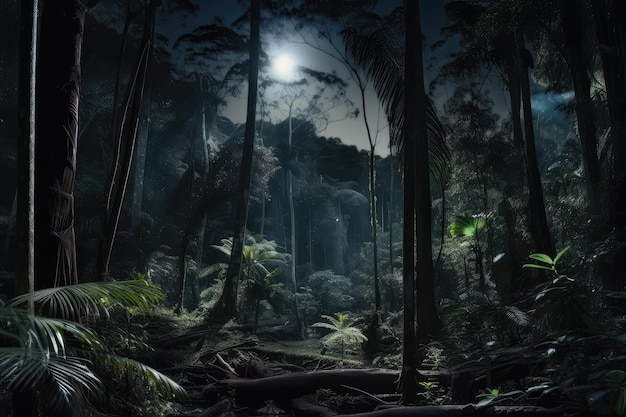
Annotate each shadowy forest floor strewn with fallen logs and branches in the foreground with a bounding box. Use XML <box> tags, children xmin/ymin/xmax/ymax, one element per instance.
<box><xmin>142</xmin><ymin>310</ymin><xmax>565</xmax><ymax>417</ymax></box>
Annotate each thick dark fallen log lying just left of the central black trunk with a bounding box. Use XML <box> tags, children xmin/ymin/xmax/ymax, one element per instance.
<box><xmin>203</xmin><ymin>369</ymin><xmax>399</xmax><ymax>402</ymax></box>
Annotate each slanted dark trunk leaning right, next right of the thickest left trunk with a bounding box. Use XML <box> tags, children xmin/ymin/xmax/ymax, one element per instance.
<box><xmin>98</xmin><ymin>1</ymin><xmax>158</xmax><ymax>281</ymax></box>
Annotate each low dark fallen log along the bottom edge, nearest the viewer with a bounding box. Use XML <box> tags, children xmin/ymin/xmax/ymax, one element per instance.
<box><xmin>335</xmin><ymin>404</ymin><xmax>563</xmax><ymax>417</ymax></box>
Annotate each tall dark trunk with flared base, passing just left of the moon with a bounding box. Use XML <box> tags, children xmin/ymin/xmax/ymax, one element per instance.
<box><xmin>213</xmin><ymin>0</ymin><xmax>261</xmax><ymax>318</ymax></box>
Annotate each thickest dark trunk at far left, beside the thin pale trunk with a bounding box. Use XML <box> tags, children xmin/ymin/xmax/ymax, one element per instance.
<box><xmin>34</xmin><ymin>0</ymin><xmax>86</xmax><ymax>289</ymax></box>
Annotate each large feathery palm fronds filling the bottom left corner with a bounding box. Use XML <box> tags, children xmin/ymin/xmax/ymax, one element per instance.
<box><xmin>0</xmin><ymin>280</ymin><xmax>186</xmax><ymax>416</ymax></box>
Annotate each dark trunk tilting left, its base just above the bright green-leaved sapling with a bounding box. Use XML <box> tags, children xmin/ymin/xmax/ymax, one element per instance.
<box><xmin>513</xmin><ymin>31</ymin><xmax>554</xmax><ymax>256</ymax></box>
